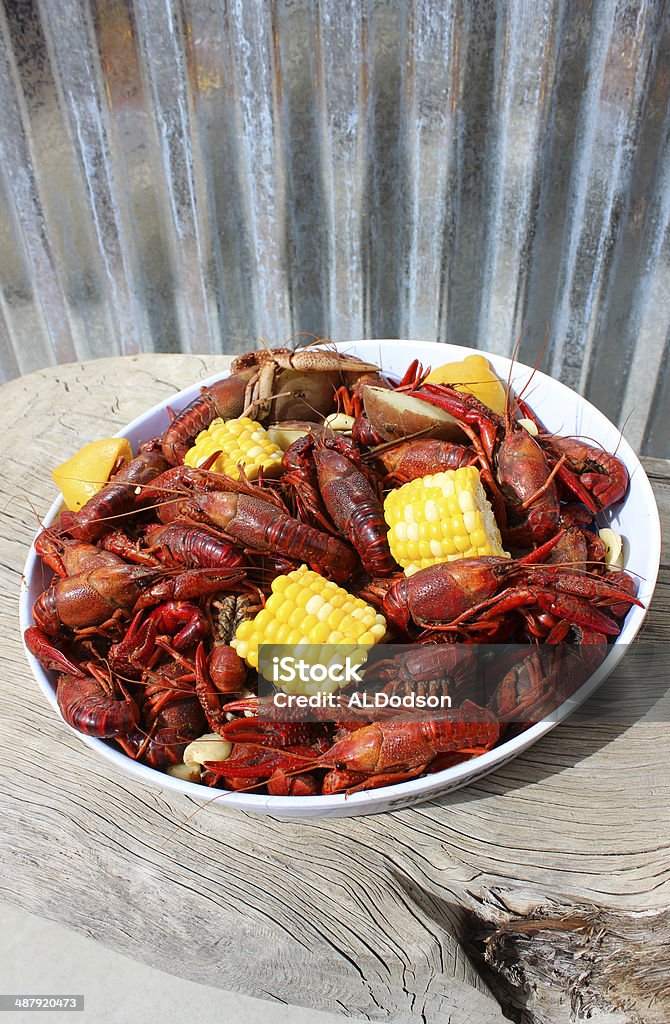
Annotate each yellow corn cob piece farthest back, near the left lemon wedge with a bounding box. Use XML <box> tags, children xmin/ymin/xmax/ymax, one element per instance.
<box><xmin>183</xmin><ymin>416</ymin><xmax>283</xmax><ymax>480</ymax></box>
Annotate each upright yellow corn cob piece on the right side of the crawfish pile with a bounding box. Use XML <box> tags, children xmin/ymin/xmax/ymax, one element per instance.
<box><xmin>384</xmin><ymin>466</ymin><xmax>507</xmax><ymax>575</ymax></box>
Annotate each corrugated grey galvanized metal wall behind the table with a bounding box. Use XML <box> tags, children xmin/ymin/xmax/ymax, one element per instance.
<box><xmin>0</xmin><ymin>0</ymin><xmax>670</xmax><ymax>456</ymax></box>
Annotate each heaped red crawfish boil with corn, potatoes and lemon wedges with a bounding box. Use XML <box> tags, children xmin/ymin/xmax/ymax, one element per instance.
<box><xmin>25</xmin><ymin>344</ymin><xmax>640</xmax><ymax>797</ymax></box>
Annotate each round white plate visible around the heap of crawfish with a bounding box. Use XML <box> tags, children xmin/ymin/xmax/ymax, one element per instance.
<box><xmin>19</xmin><ymin>340</ymin><xmax>661</xmax><ymax>818</ymax></box>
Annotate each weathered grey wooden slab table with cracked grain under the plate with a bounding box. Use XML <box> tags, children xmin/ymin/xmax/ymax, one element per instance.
<box><xmin>0</xmin><ymin>355</ymin><xmax>670</xmax><ymax>1024</ymax></box>
